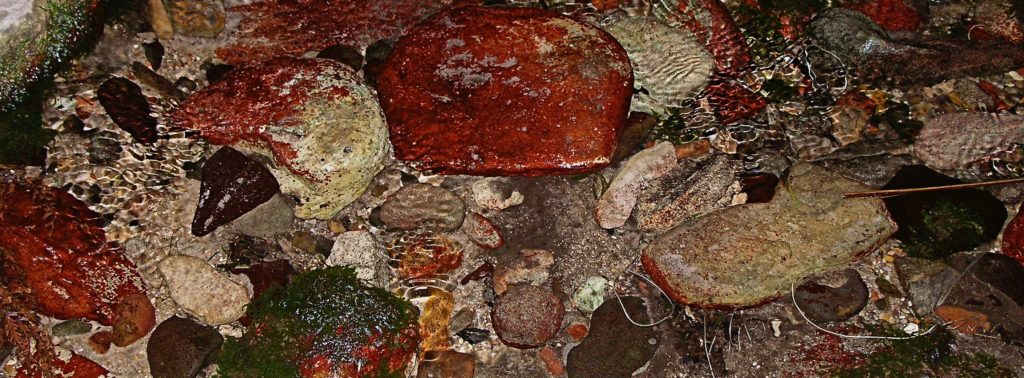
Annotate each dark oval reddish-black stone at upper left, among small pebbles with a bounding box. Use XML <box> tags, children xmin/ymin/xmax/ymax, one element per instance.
<box><xmin>96</xmin><ymin>76</ymin><xmax>157</xmax><ymax>144</ymax></box>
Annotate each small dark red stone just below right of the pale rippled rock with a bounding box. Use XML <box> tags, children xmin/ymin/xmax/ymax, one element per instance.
<box><xmin>697</xmin><ymin>81</ymin><xmax>768</xmax><ymax>125</ymax></box>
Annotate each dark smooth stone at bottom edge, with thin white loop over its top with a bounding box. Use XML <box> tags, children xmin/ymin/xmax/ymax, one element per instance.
<box><xmin>566</xmin><ymin>297</ymin><xmax>659</xmax><ymax>377</ymax></box>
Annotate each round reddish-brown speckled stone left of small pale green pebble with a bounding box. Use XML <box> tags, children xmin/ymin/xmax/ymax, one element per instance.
<box><xmin>490</xmin><ymin>285</ymin><xmax>565</xmax><ymax>349</ymax></box>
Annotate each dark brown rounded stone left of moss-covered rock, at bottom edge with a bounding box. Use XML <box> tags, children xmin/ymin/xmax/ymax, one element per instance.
<box><xmin>145</xmin><ymin>317</ymin><xmax>224</xmax><ymax>378</ymax></box>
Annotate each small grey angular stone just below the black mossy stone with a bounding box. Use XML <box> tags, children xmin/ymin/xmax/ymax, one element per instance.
<box><xmin>895</xmin><ymin>256</ymin><xmax>959</xmax><ymax>317</ymax></box>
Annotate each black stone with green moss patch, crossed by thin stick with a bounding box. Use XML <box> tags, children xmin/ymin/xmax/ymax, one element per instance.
<box><xmin>883</xmin><ymin>165</ymin><xmax>1007</xmax><ymax>259</ymax></box>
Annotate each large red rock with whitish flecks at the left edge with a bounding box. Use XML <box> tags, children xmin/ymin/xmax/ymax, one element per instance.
<box><xmin>0</xmin><ymin>182</ymin><xmax>156</xmax><ymax>345</ymax></box>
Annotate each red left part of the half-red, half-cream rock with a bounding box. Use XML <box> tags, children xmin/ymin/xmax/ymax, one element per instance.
<box><xmin>170</xmin><ymin>56</ymin><xmax>350</xmax><ymax>178</ymax></box>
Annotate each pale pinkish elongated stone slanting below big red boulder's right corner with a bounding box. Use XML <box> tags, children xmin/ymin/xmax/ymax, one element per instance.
<box><xmin>594</xmin><ymin>141</ymin><xmax>676</xmax><ymax>228</ymax></box>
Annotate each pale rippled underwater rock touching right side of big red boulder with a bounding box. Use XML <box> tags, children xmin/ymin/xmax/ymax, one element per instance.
<box><xmin>605</xmin><ymin>17</ymin><xmax>715</xmax><ymax>111</ymax></box>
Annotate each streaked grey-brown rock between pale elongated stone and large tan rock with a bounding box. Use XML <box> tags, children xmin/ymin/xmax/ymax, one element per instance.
<box><xmin>635</xmin><ymin>155</ymin><xmax>742</xmax><ymax>233</ymax></box>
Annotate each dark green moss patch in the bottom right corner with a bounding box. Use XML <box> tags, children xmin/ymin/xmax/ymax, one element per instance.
<box><xmin>833</xmin><ymin>326</ymin><xmax>1016</xmax><ymax>377</ymax></box>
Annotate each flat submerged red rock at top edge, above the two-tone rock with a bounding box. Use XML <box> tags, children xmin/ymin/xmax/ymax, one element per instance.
<box><xmin>217</xmin><ymin>0</ymin><xmax>451</xmax><ymax>65</ymax></box>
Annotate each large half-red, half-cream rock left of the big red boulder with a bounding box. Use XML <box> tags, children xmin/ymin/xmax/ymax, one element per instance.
<box><xmin>170</xmin><ymin>57</ymin><xmax>388</xmax><ymax>219</ymax></box>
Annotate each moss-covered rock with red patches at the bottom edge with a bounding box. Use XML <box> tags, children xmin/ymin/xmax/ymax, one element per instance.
<box><xmin>218</xmin><ymin>266</ymin><xmax>417</xmax><ymax>377</ymax></box>
